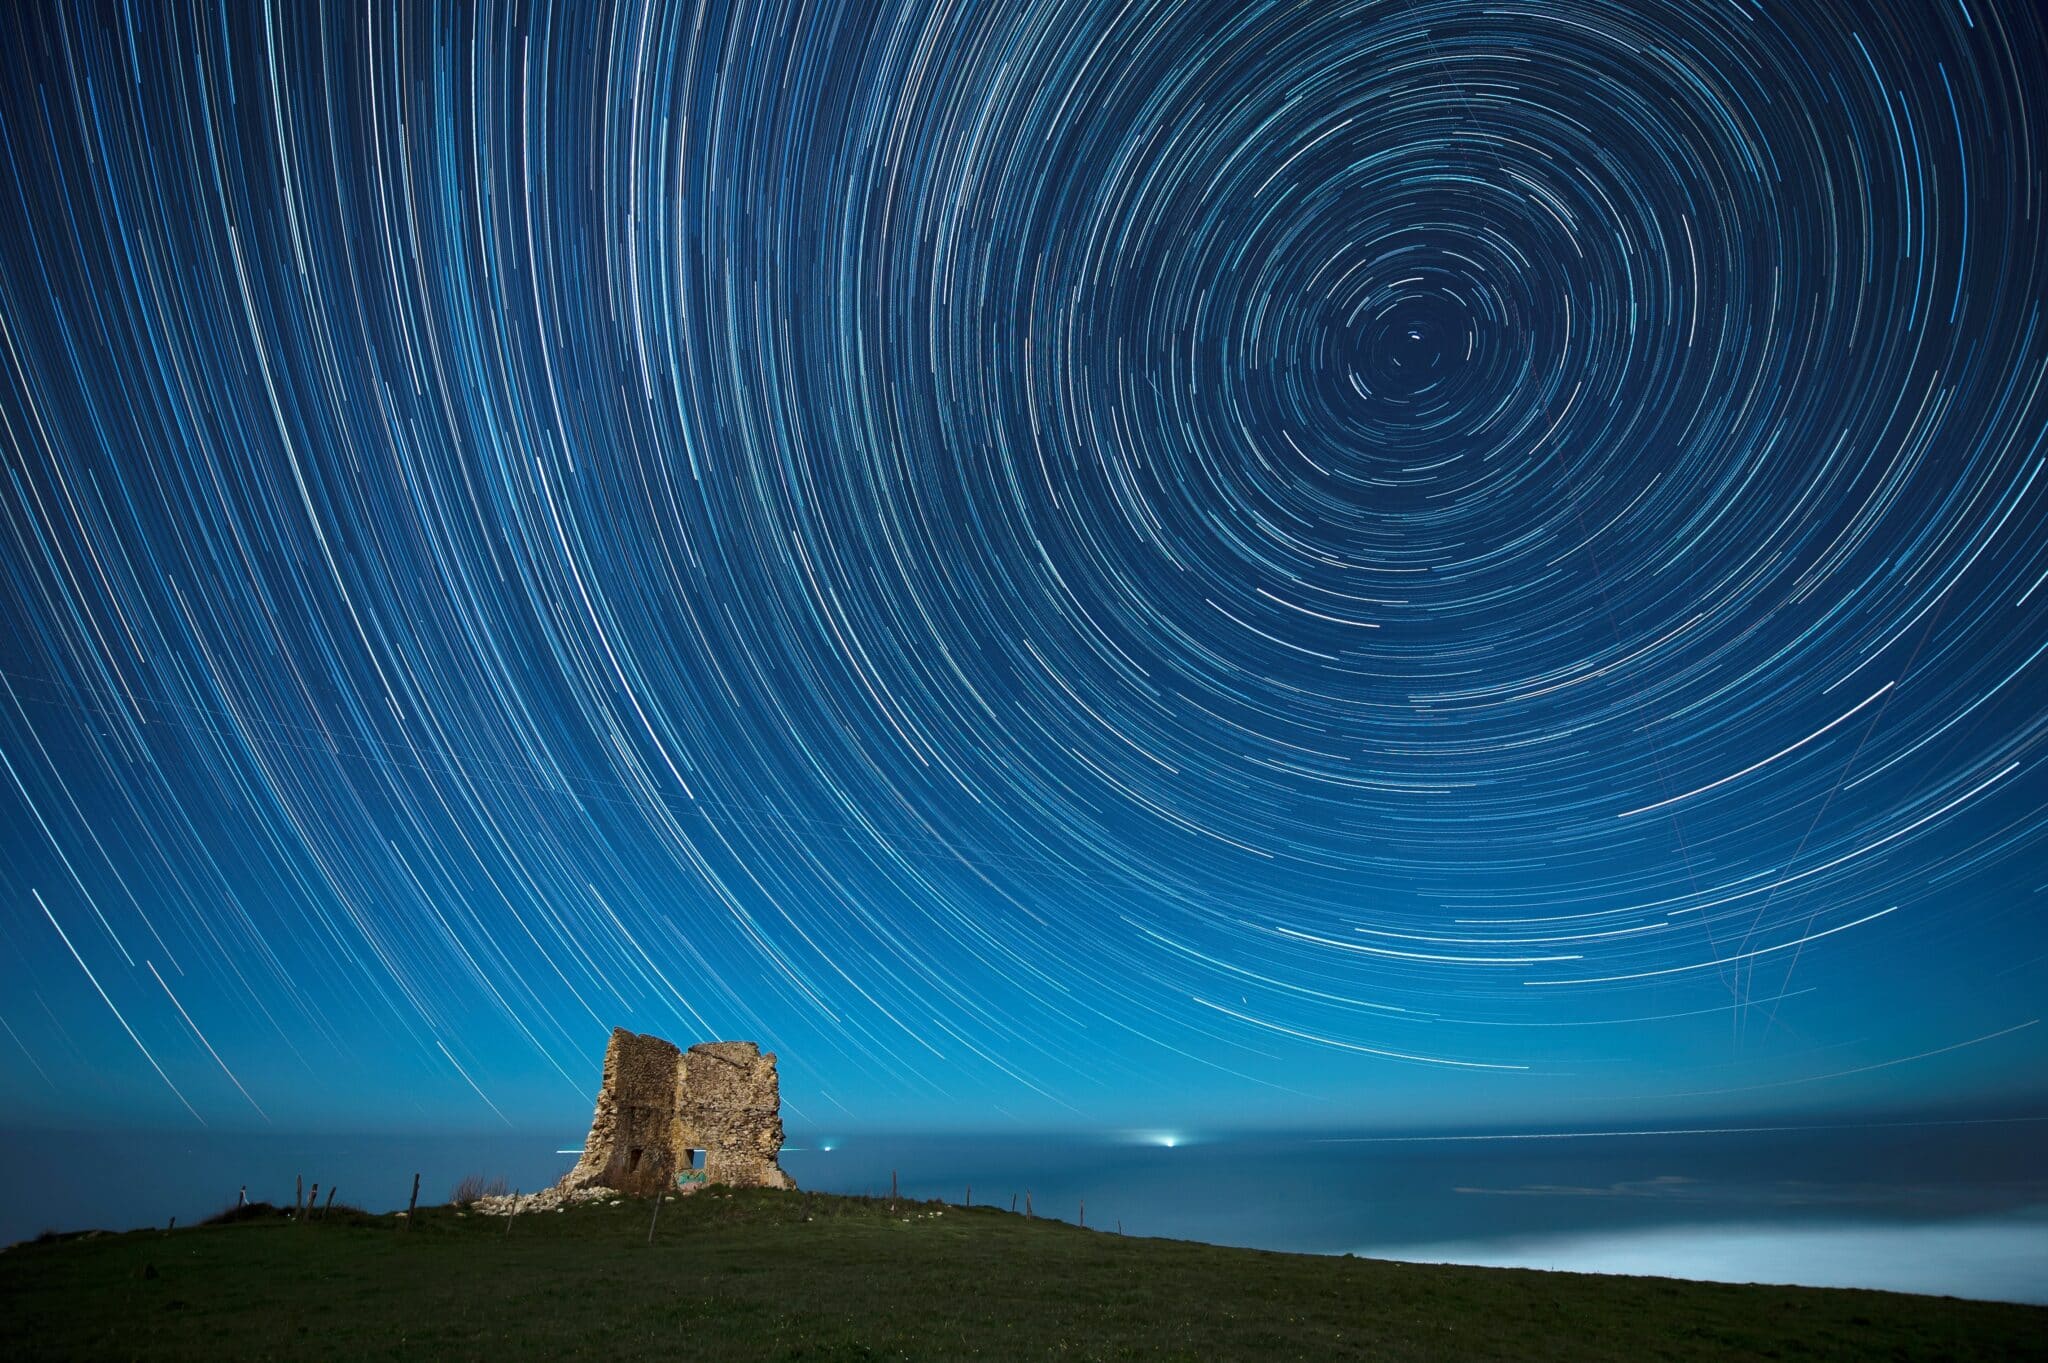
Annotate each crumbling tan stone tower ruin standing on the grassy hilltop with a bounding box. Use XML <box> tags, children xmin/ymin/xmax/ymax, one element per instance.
<box><xmin>561</xmin><ymin>1027</ymin><xmax>797</xmax><ymax>1197</ymax></box>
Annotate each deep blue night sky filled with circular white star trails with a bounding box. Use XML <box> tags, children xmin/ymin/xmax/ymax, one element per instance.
<box><xmin>0</xmin><ymin>0</ymin><xmax>2048</xmax><ymax>1134</ymax></box>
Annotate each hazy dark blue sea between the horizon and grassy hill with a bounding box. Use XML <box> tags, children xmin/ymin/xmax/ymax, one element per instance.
<box><xmin>0</xmin><ymin>1119</ymin><xmax>2048</xmax><ymax>1304</ymax></box>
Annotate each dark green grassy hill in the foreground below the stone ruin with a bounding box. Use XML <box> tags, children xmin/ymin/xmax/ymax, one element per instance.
<box><xmin>0</xmin><ymin>1191</ymin><xmax>2048</xmax><ymax>1363</ymax></box>
